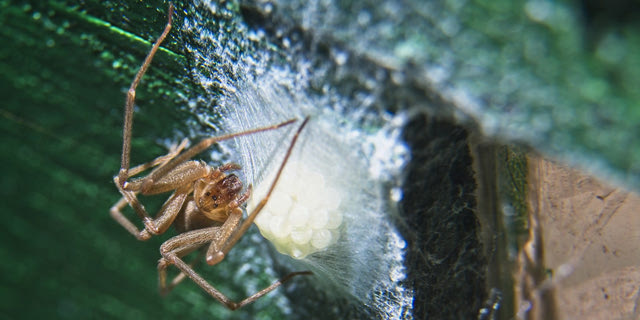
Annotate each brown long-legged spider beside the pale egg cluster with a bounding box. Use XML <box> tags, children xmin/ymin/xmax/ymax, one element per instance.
<box><xmin>110</xmin><ymin>3</ymin><xmax>311</xmax><ymax>310</ymax></box>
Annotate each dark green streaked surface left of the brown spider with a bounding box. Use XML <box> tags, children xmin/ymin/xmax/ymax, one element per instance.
<box><xmin>0</xmin><ymin>1</ymin><xmax>241</xmax><ymax>319</ymax></box>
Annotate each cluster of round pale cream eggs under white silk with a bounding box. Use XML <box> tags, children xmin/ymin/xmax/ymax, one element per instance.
<box><xmin>248</xmin><ymin>161</ymin><xmax>343</xmax><ymax>259</ymax></box>
